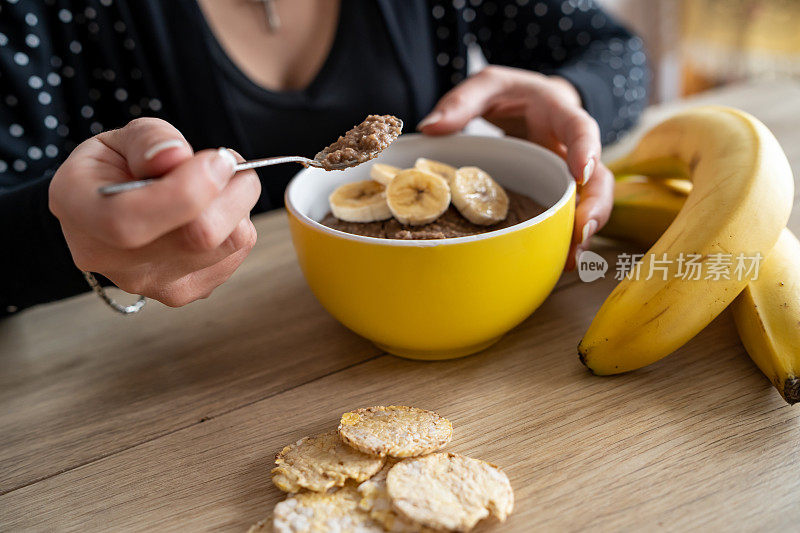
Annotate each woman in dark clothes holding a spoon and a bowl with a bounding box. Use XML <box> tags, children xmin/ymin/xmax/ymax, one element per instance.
<box><xmin>0</xmin><ymin>0</ymin><xmax>647</xmax><ymax>313</ymax></box>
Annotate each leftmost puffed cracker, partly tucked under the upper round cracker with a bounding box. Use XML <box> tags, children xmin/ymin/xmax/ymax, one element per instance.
<box><xmin>272</xmin><ymin>431</ymin><xmax>385</xmax><ymax>492</ymax></box>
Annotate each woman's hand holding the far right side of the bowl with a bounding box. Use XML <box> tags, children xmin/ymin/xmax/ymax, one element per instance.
<box><xmin>417</xmin><ymin>66</ymin><xmax>614</xmax><ymax>270</ymax></box>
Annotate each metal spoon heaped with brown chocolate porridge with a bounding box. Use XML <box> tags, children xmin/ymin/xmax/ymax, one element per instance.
<box><xmin>98</xmin><ymin>115</ymin><xmax>403</xmax><ymax>196</ymax></box>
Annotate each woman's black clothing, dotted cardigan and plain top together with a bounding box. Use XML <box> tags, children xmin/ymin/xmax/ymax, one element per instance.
<box><xmin>0</xmin><ymin>0</ymin><xmax>648</xmax><ymax>315</ymax></box>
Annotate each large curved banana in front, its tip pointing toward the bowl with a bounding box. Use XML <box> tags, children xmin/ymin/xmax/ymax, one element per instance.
<box><xmin>578</xmin><ymin>107</ymin><xmax>794</xmax><ymax>375</ymax></box>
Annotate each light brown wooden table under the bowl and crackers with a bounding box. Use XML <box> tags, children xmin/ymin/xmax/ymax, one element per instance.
<box><xmin>0</xmin><ymin>83</ymin><xmax>800</xmax><ymax>531</ymax></box>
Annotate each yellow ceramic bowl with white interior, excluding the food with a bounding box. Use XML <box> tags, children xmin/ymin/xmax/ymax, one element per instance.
<box><xmin>286</xmin><ymin>135</ymin><xmax>575</xmax><ymax>359</ymax></box>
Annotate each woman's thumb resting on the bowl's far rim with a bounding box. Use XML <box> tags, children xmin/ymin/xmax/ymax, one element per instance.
<box><xmin>417</xmin><ymin>67</ymin><xmax>503</xmax><ymax>135</ymax></box>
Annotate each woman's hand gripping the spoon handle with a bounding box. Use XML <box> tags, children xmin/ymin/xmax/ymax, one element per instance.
<box><xmin>50</xmin><ymin>118</ymin><xmax>261</xmax><ymax>307</ymax></box>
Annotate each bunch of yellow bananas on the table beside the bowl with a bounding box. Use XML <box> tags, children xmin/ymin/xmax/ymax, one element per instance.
<box><xmin>578</xmin><ymin>107</ymin><xmax>800</xmax><ymax>404</ymax></box>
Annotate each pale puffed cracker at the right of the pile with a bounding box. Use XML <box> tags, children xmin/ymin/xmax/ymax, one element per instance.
<box><xmin>386</xmin><ymin>452</ymin><xmax>514</xmax><ymax>531</ymax></box>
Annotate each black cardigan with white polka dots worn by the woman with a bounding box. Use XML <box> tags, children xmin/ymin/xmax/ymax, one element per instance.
<box><xmin>0</xmin><ymin>0</ymin><xmax>648</xmax><ymax>315</ymax></box>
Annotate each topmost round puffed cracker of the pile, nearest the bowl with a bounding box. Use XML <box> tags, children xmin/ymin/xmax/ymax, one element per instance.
<box><xmin>339</xmin><ymin>405</ymin><xmax>453</xmax><ymax>458</ymax></box>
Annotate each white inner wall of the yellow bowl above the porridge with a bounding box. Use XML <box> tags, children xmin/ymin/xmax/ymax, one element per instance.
<box><xmin>286</xmin><ymin>134</ymin><xmax>575</xmax><ymax>240</ymax></box>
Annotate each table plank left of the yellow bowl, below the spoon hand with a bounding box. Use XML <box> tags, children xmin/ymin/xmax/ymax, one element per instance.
<box><xmin>0</xmin><ymin>213</ymin><xmax>381</xmax><ymax>490</ymax></box>
